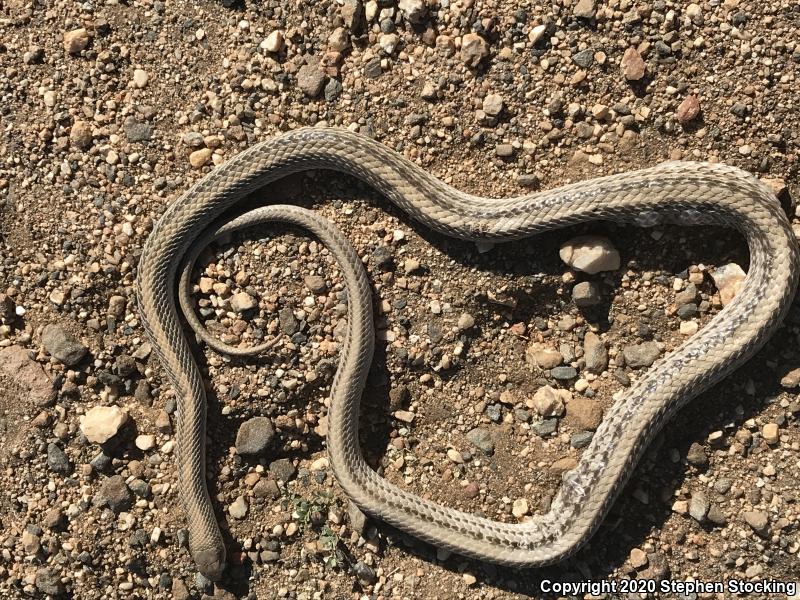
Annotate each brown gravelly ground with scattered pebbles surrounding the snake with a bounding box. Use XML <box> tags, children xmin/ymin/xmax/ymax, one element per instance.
<box><xmin>0</xmin><ymin>0</ymin><xmax>800</xmax><ymax>599</ymax></box>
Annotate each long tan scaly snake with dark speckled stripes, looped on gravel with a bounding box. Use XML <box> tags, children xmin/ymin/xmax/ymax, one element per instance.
<box><xmin>136</xmin><ymin>127</ymin><xmax>800</xmax><ymax>580</ymax></box>
